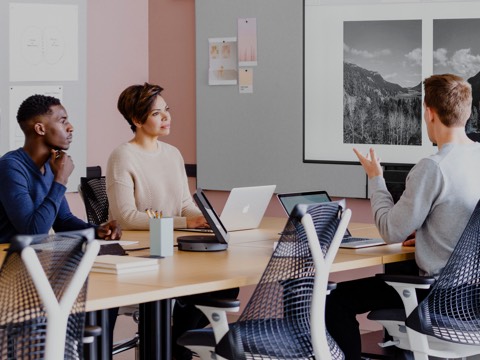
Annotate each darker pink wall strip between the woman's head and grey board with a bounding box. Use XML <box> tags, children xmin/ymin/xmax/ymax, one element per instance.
<box><xmin>149</xmin><ymin>0</ymin><xmax>196</xmax><ymax>164</ymax></box>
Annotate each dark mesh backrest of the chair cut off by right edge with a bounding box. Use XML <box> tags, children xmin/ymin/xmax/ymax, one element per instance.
<box><xmin>406</xmin><ymin>198</ymin><xmax>480</xmax><ymax>345</ymax></box>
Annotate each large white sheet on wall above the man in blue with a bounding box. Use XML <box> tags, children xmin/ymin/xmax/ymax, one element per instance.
<box><xmin>9</xmin><ymin>3</ymin><xmax>79</xmax><ymax>81</ymax></box>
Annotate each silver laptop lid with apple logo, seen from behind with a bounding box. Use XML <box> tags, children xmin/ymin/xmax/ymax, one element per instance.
<box><xmin>220</xmin><ymin>185</ymin><xmax>276</xmax><ymax>231</ymax></box>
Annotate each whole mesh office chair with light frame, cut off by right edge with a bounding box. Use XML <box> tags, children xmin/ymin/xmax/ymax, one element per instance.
<box><xmin>368</xmin><ymin>202</ymin><xmax>480</xmax><ymax>360</ymax></box>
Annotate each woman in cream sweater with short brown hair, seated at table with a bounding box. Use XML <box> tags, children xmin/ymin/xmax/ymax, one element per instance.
<box><xmin>106</xmin><ymin>83</ymin><xmax>239</xmax><ymax>360</ymax></box>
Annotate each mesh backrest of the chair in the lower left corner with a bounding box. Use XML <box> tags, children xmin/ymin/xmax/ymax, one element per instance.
<box><xmin>0</xmin><ymin>231</ymin><xmax>98</xmax><ymax>359</ymax></box>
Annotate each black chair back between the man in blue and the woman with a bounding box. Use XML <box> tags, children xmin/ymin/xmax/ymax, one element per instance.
<box><xmin>80</xmin><ymin>176</ymin><xmax>108</xmax><ymax>225</ymax></box>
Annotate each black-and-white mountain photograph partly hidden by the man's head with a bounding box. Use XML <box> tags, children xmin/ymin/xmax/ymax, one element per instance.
<box><xmin>433</xmin><ymin>19</ymin><xmax>480</xmax><ymax>141</ymax></box>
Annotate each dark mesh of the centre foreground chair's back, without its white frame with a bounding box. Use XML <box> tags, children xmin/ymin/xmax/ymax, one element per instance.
<box><xmin>225</xmin><ymin>203</ymin><xmax>343</xmax><ymax>359</ymax></box>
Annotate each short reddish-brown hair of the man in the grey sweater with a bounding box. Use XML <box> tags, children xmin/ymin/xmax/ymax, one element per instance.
<box><xmin>423</xmin><ymin>74</ymin><xmax>472</xmax><ymax>127</ymax></box>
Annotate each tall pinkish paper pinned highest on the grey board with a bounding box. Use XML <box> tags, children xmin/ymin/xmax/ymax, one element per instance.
<box><xmin>237</xmin><ymin>18</ymin><xmax>257</xmax><ymax>66</ymax></box>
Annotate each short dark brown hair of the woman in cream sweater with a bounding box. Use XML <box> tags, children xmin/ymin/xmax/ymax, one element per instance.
<box><xmin>117</xmin><ymin>83</ymin><xmax>163</xmax><ymax>132</ymax></box>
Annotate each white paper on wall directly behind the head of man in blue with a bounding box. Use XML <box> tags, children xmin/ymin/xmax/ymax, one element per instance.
<box><xmin>8</xmin><ymin>85</ymin><xmax>63</xmax><ymax>150</ymax></box>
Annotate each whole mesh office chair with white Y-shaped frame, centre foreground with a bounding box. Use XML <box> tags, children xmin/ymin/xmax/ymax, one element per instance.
<box><xmin>178</xmin><ymin>203</ymin><xmax>351</xmax><ymax>359</ymax></box>
